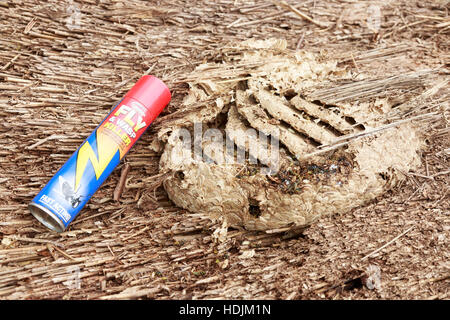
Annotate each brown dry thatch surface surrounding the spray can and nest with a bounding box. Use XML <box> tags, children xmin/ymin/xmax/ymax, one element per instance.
<box><xmin>0</xmin><ymin>0</ymin><xmax>450</xmax><ymax>299</ymax></box>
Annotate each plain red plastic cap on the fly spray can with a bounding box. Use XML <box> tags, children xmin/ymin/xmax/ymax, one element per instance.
<box><xmin>125</xmin><ymin>75</ymin><xmax>172</xmax><ymax>116</ymax></box>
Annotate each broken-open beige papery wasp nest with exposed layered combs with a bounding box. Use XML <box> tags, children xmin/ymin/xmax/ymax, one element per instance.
<box><xmin>155</xmin><ymin>39</ymin><xmax>423</xmax><ymax>230</ymax></box>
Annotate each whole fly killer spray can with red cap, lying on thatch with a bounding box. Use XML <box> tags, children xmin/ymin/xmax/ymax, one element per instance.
<box><xmin>29</xmin><ymin>76</ymin><xmax>171</xmax><ymax>232</ymax></box>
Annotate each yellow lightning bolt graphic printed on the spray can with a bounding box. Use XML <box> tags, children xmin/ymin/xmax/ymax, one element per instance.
<box><xmin>75</xmin><ymin>128</ymin><xmax>118</xmax><ymax>190</ymax></box>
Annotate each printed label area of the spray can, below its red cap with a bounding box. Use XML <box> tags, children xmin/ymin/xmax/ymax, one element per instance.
<box><xmin>33</xmin><ymin>98</ymin><xmax>153</xmax><ymax>227</ymax></box>
